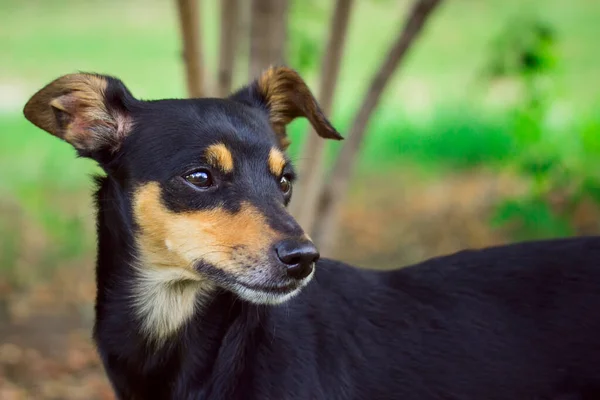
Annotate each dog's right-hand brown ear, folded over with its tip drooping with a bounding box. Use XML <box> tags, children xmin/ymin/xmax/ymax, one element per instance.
<box><xmin>230</xmin><ymin>67</ymin><xmax>343</xmax><ymax>149</ymax></box>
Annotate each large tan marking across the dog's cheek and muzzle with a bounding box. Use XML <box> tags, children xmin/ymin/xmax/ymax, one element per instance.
<box><xmin>134</xmin><ymin>183</ymin><xmax>279</xmax><ymax>275</ymax></box>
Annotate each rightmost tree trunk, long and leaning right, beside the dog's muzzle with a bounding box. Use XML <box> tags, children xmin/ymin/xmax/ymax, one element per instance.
<box><xmin>313</xmin><ymin>0</ymin><xmax>441</xmax><ymax>255</ymax></box>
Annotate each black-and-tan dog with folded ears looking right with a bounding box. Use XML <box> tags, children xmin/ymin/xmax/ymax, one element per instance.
<box><xmin>24</xmin><ymin>66</ymin><xmax>600</xmax><ymax>400</ymax></box>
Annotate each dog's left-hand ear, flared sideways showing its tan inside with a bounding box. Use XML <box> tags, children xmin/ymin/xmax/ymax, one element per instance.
<box><xmin>23</xmin><ymin>73</ymin><xmax>135</xmax><ymax>157</ymax></box>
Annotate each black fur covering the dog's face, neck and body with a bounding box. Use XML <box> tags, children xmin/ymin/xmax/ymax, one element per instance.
<box><xmin>25</xmin><ymin>72</ymin><xmax>600</xmax><ymax>400</ymax></box>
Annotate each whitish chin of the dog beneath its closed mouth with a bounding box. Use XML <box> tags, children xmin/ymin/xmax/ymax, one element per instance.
<box><xmin>228</xmin><ymin>270</ymin><xmax>314</xmax><ymax>305</ymax></box>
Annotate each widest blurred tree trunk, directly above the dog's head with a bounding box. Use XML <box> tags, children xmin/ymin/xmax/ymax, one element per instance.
<box><xmin>248</xmin><ymin>0</ymin><xmax>288</xmax><ymax>79</ymax></box>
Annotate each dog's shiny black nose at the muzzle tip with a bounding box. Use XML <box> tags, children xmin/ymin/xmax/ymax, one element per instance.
<box><xmin>275</xmin><ymin>239</ymin><xmax>319</xmax><ymax>279</ymax></box>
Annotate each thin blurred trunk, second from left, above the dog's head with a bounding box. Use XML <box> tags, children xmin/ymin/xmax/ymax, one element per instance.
<box><xmin>217</xmin><ymin>0</ymin><xmax>239</xmax><ymax>97</ymax></box>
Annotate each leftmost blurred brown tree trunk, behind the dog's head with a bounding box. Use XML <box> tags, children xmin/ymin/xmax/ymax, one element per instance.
<box><xmin>177</xmin><ymin>0</ymin><xmax>204</xmax><ymax>97</ymax></box>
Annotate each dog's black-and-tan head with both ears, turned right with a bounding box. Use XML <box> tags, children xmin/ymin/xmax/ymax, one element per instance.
<box><xmin>24</xmin><ymin>67</ymin><xmax>341</xmax><ymax>304</ymax></box>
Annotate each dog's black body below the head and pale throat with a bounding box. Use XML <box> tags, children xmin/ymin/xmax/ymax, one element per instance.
<box><xmin>96</xmin><ymin>227</ymin><xmax>600</xmax><ymax>400</ymax></box>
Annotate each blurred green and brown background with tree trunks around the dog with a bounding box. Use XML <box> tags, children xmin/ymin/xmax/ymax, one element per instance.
<box><xmin>0</xmin><ymin>0</ymin><xmax>600</xmax><ymax>400</ymax></box>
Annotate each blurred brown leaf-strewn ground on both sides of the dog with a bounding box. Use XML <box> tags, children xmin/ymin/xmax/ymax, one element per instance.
<box><xmin>0</xmin><ymin>172</ymin><xmax>598</xmax><ymax>400</ymax></box>
